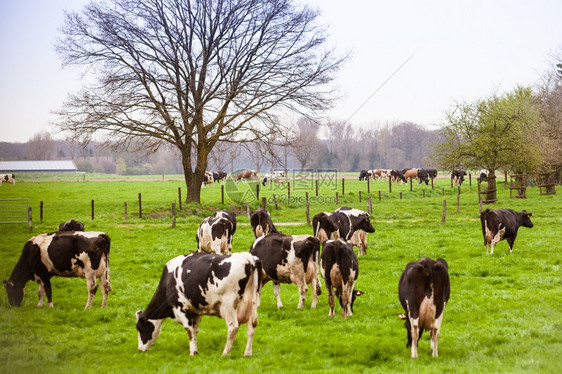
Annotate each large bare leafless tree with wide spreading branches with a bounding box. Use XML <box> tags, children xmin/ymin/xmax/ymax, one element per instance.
<box><xmin>56</xmin><ymin>0</ymin><xmax>344</xmax><ymax>202</ymax></box>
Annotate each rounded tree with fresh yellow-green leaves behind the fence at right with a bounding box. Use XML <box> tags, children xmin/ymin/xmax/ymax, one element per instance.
<box><xmin>434</xmin><ymin>87</ymin><xmax>542</xmax><ymax>200</ymax></box>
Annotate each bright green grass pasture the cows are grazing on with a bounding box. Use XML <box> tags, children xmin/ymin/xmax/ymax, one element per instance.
<box><xmin>0</xmin><ymin>174</ymin><xmax>562</xmax><ymax>373</ymax></box>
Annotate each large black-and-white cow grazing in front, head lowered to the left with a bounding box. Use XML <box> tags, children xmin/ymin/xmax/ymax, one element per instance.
<box><xmin>136</xmin><ymin>252</ymin><xmax>262</xmax><ymax>356</ymax></box>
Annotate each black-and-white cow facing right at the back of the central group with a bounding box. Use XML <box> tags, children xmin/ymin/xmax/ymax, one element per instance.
<box><xmin>312</xmin><ymin>207</ymin><xmax>375</xmax><ymax>250</ymax></box>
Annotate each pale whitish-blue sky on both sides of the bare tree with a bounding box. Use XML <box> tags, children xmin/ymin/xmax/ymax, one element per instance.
<box><xmin>0</xmin><ymin>0</ymin><xmax>562</xmax><ymax>142</ymax></box>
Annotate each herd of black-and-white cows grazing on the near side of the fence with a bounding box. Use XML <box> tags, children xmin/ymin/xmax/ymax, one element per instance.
<box><xmin>3</xmin><ymin>193</ymin><xmax>533</xmax><ymax>358</ymax></box>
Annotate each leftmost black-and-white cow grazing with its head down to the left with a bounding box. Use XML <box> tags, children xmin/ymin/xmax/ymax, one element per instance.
<box><xmin>3</xmin><ymin>231</ymin><xmax>112</xmax><ymax>309</ymax></box>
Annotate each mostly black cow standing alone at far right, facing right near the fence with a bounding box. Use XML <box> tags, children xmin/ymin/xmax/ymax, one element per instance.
<box><xmin>480</xmin><ymin>209</ymin><xmax>533</xmax><ymax>254</ymax></box>
